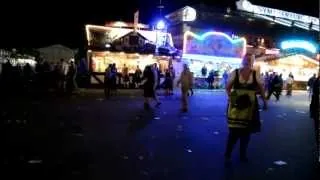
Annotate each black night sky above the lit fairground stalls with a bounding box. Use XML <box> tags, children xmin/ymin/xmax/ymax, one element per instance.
<box><xmin>0</xmin><ymin>0</ymin><xmax>319</xmax><ymax>47</ymax></box>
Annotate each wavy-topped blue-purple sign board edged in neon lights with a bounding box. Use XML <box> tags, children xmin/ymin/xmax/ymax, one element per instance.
<box><xmin>183</xmin><ymin>31</ymin><xmax>247</xmax><ymax>58</ymax></box>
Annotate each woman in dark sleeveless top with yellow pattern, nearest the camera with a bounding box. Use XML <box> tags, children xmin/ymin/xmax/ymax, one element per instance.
<box><xmin>225</xmin><ymin>54</ymin><xmax>267</xmax><ymax>163</ymax></box>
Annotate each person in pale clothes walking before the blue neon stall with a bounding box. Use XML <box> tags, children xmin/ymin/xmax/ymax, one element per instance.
<box><xmin>177</xmin><ymin>64</ymin><xmax>193</xmax><ymax>112</ymax></box>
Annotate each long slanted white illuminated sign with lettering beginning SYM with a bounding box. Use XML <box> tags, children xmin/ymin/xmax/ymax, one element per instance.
<box><xmin>236</xmin><ymin>0</ymin><xmax>319</xmax><ymax>25</ymax></box>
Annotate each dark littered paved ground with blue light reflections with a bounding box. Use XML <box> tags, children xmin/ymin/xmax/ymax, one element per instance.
<box><xmin>1</xmin><ymin>91</ymin><xmax>320</xmax><ymax>180</ymax></box>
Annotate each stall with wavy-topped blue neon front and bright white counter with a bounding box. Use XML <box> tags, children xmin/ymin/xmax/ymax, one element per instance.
<box><xmin>182</xmin><ymin>31</ymin><xmax>246</xmax><ymax>77</ymax></box>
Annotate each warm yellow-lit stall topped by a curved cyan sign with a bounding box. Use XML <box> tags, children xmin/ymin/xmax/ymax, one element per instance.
<box><xmin>255</xmin><ymin>40</ymin><xmax>319</xmax><ymax>89</ymax></box>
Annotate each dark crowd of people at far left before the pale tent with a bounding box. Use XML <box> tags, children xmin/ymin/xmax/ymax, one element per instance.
<box><xmin>0</xmin><ymin>59</ymin><xmax>77</xmax><ymax>96</ymax></box>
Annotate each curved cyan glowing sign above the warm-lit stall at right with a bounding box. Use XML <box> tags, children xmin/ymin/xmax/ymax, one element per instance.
<box><xmin>281</xmin><ymin>40</ymin><xmax>317</xmax><ymax>53</ymax></box>
